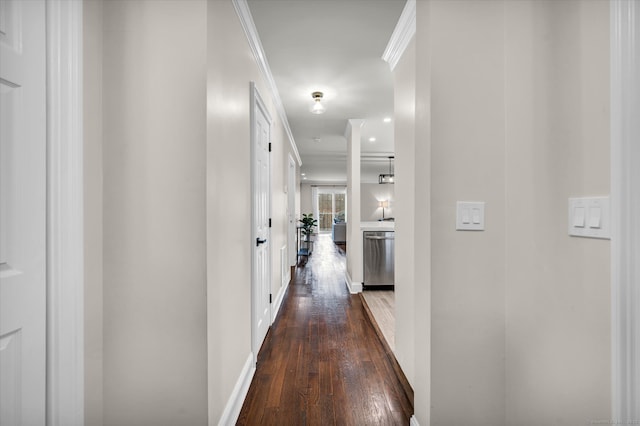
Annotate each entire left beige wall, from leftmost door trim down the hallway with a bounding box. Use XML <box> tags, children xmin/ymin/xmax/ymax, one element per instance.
<box><xmin>84</xmin><ymin>0</ymin><xmax>300</xmax><ymax>425</ymax></box>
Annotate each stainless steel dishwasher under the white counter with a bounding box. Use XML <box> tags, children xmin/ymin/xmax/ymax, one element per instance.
<box><xmin>362</xmin><ymin>231</ymin><xmax>395</xmax><ymax>288</ymax></box>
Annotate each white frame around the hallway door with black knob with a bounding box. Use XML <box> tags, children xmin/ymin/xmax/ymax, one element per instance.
<box><xmin>250</xmin><ymin>81</ymin><xmax>273</xmax><ymax>364</ymax></box>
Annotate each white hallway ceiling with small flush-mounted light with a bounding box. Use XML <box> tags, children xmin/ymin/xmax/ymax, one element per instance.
<box><xmin>248</xmin><ymin>0</ymin><xmax>406</xmax><ymax>183</ymax></box>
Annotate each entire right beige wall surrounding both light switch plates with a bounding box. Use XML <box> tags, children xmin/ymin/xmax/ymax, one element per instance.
<box><xmin>408</xmin><ymin>0</ymin><xmax>610</xmax><ymax>425</ymax></box>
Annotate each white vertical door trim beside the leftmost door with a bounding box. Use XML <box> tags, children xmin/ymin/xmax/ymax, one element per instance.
<box><xmin>46</xmin><ymin>0</ymin><xmax>84</xmax><ymax>426</ymax></box>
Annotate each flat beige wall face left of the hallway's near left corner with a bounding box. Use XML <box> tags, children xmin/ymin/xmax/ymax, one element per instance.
<box><xmin>102</xmin><ymin>0</ymin><xmax>207</xmax><ymax>425</ymax></box>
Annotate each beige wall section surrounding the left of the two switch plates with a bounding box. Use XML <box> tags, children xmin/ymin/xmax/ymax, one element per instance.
<box><xmin>428</xmin><ymin>1</ymin><xmax>505</xmax><ymax>425</ymax></box>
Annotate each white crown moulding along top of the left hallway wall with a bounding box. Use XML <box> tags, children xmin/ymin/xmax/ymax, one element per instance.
<box><xmin>232</xmin><ymin>0</ymin><xmax>302</xmax><ymax>166</ymax></box>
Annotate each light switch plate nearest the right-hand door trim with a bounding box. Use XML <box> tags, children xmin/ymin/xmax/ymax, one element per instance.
<box><xmin>569</xmin><ymin>197</ymin><xmax>611</xmax><ymax>240</ymax></box>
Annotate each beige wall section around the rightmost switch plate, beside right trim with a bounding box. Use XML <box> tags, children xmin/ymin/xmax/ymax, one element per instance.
<box><xmin>505</xmin><ymin>1</ymin><xmax>611</xmax><ymax>425</ymax></box>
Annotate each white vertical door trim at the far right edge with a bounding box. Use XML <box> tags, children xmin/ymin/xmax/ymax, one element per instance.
<box><xmin>611</xmin><ymin>0</ymin><xmax>640</xmax><ymax>424</ymax></box>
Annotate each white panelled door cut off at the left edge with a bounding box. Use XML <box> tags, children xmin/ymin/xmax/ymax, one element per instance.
<box><xmin>0</xmin><ymin>0</ymin><xmax>46</xmax><ymax>426</ymax></box>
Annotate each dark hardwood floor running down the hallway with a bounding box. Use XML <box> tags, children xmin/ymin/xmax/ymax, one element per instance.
<box><xmin>237</xmin><ymin>235</ymin><xmax>413</xmax><ymax>425</ymax></box>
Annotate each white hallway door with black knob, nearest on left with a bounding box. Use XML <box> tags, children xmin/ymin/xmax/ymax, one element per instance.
<box><xmin>251</xmin><ymin>85</ymin><xmax>271</xmax><ymax>357</ymax></box>
